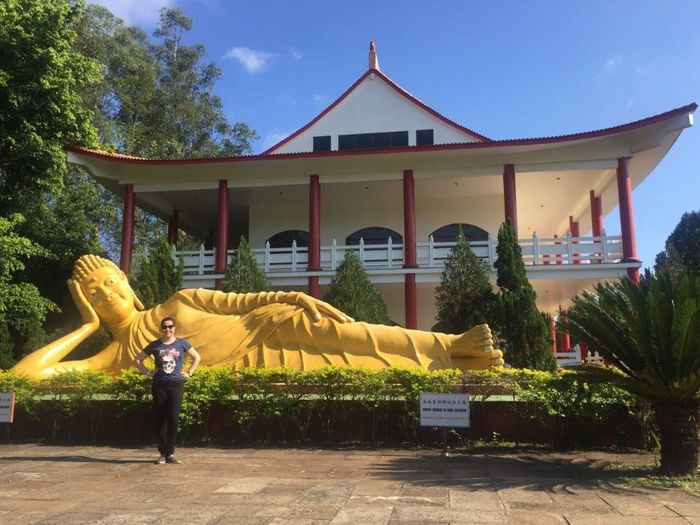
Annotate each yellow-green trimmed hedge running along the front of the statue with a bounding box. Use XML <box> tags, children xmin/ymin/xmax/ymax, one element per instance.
<box><xmin>0</xmin><ymin>367</ymin><xmax>645</xmax><ymax>442</ymax></box>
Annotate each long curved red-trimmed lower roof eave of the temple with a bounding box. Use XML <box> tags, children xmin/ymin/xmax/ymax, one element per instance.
<box><xmin>64</xmin><ymin>102</ymin><xmax>698</xmax><ymax>165</ymax></box>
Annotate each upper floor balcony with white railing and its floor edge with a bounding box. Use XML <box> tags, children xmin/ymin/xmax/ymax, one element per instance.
<box><xmin>173</xmin><ymin>232</ymin><xmax>640</xmax><ymax>287</ymax></box>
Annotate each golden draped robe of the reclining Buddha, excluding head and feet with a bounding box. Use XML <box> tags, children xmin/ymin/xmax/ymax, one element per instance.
<box><xmin>108</xmin><ymin>288</ymin><xmax>491</xmax><ymax>370</ymax></box>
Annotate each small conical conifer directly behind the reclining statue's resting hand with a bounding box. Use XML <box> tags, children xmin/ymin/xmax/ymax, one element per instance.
<box><xmin>323</xmin><ymin>251</ymin><xmax>391</xmax><ymax>324</ymax></box>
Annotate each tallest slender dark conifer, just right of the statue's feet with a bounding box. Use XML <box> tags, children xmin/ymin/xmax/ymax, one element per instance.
<box><xmin>495</xmin><ymin>219</ymin><xmax>556</xmax><ymax>370</ymax></box>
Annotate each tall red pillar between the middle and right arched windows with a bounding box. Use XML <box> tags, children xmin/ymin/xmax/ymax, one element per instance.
<box><xmin>403</xmin><ymin>170</ymin><xmax>418</xmax><ymax>329</ymax></box>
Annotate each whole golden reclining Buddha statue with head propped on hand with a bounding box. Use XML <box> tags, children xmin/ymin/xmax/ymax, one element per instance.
<box><xmin>14</xmin><ymin>255</ymin><xmax>503</xmax><ymax>379</ymax></box>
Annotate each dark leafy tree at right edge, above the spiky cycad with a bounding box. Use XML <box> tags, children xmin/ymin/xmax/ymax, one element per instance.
<box><xmin>655</xmin><ymin>210</ymin><xmax>700</xmax><ymax>274</ymax></box>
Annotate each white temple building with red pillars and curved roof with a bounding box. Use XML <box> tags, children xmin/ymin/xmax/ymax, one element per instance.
<box><xmin>68</xmin><ymin>44</ymin><xmax>697</xmax><ymax>329</ymax></box>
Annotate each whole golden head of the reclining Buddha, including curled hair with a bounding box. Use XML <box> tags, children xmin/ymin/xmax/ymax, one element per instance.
<box><xmin>72</xmin><ymin>255</ymin><xmax>144</xmax><ymax>324</ymax></box>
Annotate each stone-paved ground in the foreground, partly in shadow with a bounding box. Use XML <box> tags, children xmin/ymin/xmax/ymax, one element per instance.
<box><xmin>0</xmin><ymin>444</ymin><xmax>700</xmax><ymax>525</ymax></box>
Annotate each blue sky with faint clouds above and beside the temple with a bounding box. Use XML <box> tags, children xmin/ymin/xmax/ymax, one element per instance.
<box><xmin>95</xmin><ymin>0</ymin><xmax>700</xmax><ymax>265</ymax></box>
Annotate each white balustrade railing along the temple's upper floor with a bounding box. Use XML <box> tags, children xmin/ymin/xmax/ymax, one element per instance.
<box><xmin>173</xmin><ymin>232</ymin><xmax>622</xmax><ymax>275</ymax></box>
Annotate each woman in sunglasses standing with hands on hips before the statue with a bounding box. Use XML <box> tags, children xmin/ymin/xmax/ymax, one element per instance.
<box><xmin>134</xmin><ymin>317</ymin><xmax>200</xmax><ymax>465</ymax></box>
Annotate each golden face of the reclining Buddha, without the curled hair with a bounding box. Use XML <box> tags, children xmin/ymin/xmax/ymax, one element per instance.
<box><xmin>80</xmin><ymin>266</ymin><xmax>135</xmax><ymax>322</ymax></box>
